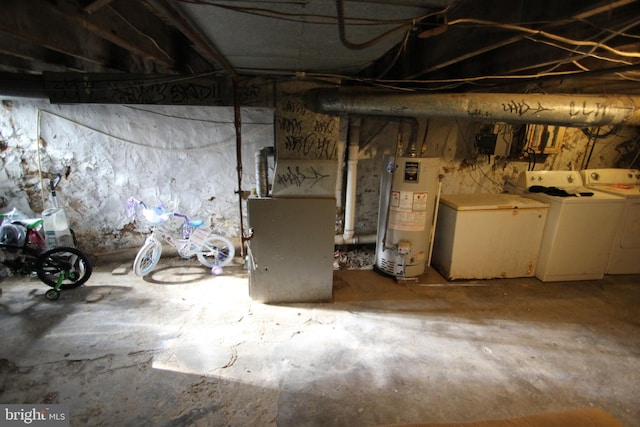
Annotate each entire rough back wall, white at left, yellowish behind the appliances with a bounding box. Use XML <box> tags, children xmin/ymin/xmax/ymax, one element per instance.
<box><xmin>0</xmin><ymin>96</ymin><xmax>637</xmax><ymax>253</ymax></box>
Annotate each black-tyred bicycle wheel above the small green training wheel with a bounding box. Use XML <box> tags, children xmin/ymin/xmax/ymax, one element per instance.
<box><xmin>35</xmin><ymin>246</ymin><xmax>93</xmax><ymax>289</ymax></box>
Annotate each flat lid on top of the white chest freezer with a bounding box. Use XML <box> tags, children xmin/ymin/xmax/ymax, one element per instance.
<box><xmin>440</xmin><ymin>193</ymin><xmax>549</xmax><ymax>211</ymax></box>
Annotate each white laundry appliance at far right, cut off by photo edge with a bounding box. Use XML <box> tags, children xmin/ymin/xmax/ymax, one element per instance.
<box><xmin>581</xmin><ymin>169</ymin><xmax>640</xmax><ymax>274</ymax></box>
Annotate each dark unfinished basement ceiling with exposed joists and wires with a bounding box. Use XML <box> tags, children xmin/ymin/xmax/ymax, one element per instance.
<box><xmin>0</xmin><ymin>0</ymin><xmax>640</xmax><ymax>94</ymax></box>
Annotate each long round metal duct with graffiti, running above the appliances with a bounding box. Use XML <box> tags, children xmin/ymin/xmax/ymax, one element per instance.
<box><xmin>307</xmin><ymin>88</ymin><xmax>640</xmax><ymax>127</ymax></box>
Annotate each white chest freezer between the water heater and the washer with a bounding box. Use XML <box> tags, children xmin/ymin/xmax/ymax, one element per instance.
<box><xmin>431</xmin><ymin>194</ymin><xmax>549</xmax><ymax>280</ymax></box>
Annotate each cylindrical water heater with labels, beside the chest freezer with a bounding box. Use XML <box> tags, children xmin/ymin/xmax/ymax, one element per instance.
<box><xmin>376</xmin><ymin>157</ymin><xmax>439</xmax><ymax>277</ymax></box>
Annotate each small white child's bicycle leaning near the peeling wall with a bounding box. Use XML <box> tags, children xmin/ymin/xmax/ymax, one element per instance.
<box><xmin>127</xmin><ymin>197</ymin><xmax>235</xmax><ymax>276</ymax></box>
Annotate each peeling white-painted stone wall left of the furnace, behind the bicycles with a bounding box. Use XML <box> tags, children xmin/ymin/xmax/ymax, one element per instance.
<box><xmin>0</xmin><ymin>100</ymin><xmax>274</xmax><ymax>252</ymax></box>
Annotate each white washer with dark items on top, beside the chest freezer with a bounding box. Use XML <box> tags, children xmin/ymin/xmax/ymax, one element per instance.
<box><xmin>518</xmin><ymin>171</ymin><xmax>625</xmax><ymax>282</ymax></box>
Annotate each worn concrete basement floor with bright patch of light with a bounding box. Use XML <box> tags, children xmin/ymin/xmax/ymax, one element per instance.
<box><xmin>0</xmin><ymin>259</ymin><xmax>640</xmax><ymax>426</ymax></box>
